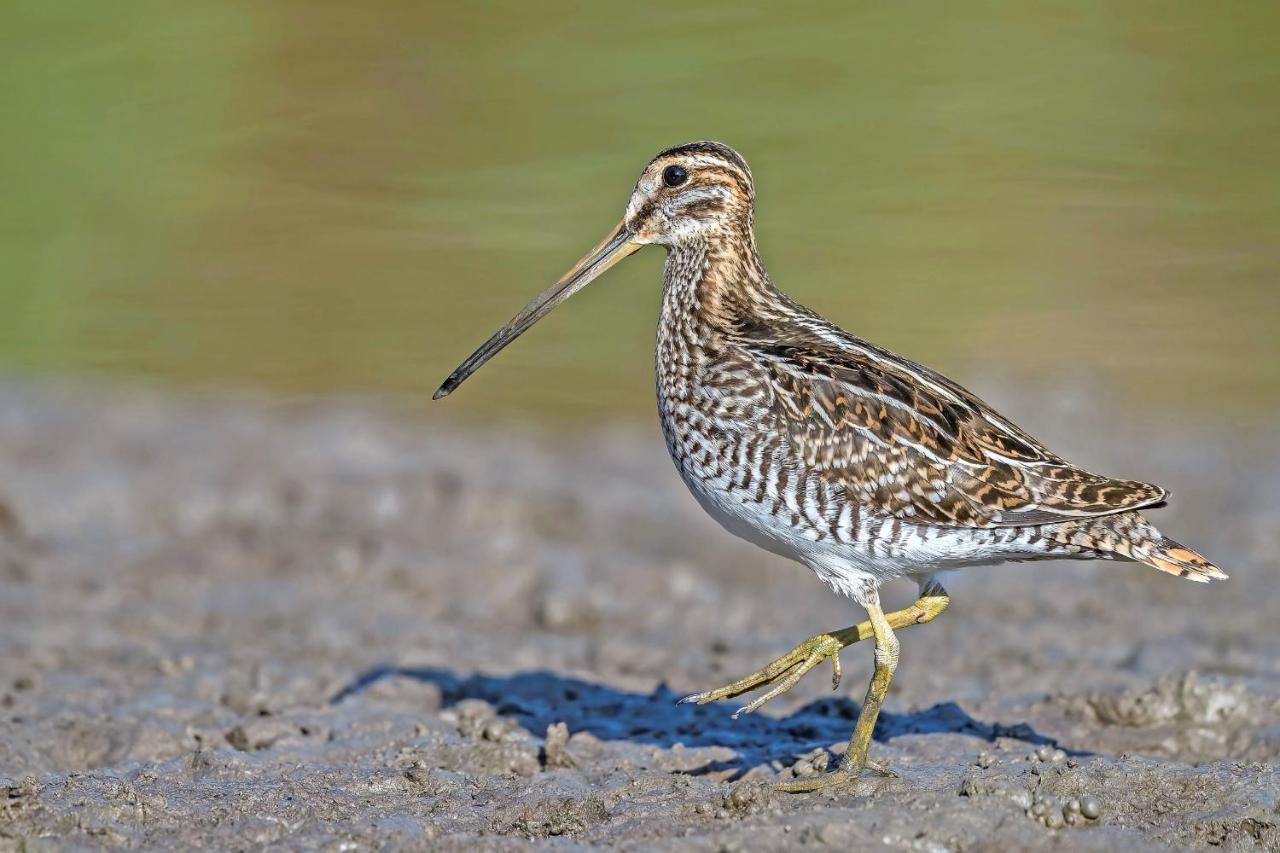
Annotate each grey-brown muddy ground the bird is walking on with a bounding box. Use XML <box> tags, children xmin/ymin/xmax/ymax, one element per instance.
<box><xmin>0</xmin><ymin>380</ymin><xmax>1280</xmax><ymax>850</ymax></box>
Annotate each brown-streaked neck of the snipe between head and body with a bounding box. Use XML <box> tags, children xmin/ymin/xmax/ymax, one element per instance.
<box><xmin>662</xmin><ymin>229</ymin><xmax>786</xmax><ymax>330</ymax></box>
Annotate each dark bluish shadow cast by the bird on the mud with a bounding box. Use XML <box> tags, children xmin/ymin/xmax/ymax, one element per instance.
<box><xmin>333</xmin><ymin>666</ymin><xmax>1085</xmax><ymax>772</ymax></box>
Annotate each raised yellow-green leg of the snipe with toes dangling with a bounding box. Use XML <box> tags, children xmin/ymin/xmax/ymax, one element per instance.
<box><xmin>680</xmin><ymin>579</ymin><xmax>950</xmax><ymax>719</ymax></box>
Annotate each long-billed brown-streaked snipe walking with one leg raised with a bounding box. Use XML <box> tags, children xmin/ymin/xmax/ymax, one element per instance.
<box><xmin>435</xmin><ymin>142</ymin><xmax>1226</xmax><ymax>790</ymax></box>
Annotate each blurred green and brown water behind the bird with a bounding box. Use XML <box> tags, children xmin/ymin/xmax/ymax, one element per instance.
<box><xmin>0</xmin><ymin>0</ymin><xmax>1280</xmax><ymax>421</ymax></box>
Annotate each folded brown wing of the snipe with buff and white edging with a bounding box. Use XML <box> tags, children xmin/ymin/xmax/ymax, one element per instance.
<box><xmin>739</xmin><ymin>330</ymin><xmax>1167</xmax><ymax>528</ymax></box>
